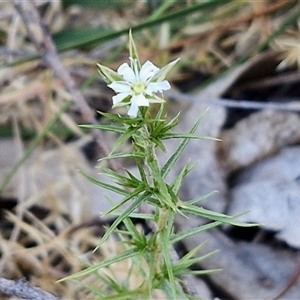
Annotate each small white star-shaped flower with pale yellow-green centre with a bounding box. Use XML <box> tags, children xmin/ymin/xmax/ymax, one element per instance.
<box><xmin>108</xmin><ymin>58</ymin><xmax>170</xmax><ymax>117</ymax></box>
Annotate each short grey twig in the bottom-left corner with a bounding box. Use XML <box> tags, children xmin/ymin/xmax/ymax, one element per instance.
<box><xmin>0</xmin><ymin>277</ymin><xmax>61</xmax><ymax>300</ymax></box>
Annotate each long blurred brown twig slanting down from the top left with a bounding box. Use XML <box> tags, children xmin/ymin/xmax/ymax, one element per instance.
<box><xmin>14</xmin><ymin>0</ymin><xmax>119</xmax><ymax>170</ymax></box>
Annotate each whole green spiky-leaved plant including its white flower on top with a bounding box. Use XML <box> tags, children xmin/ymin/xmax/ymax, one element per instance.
<box><xmin>64</xmin><ymin>32</ymin><xmax>253</xmax><ymax>299</ymax></box>
